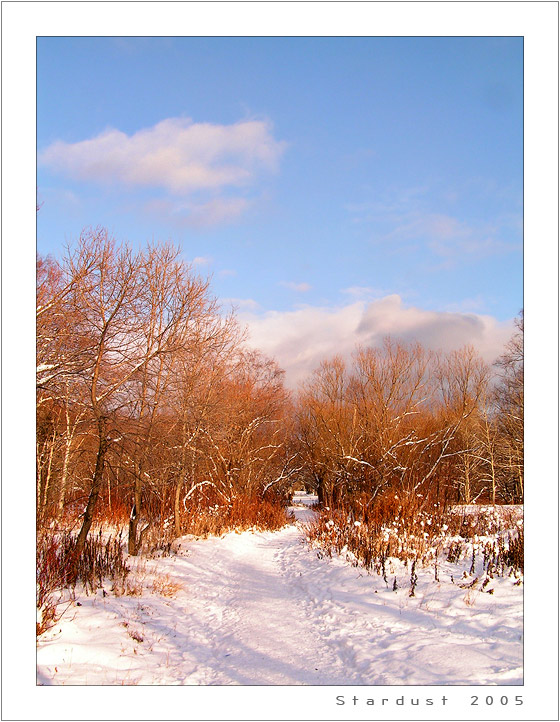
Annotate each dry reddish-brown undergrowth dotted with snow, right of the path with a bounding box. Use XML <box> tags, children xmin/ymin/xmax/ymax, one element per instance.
<box><xmin>307</xmin><ymin>498</ymin><xmax>524</xmax><ymax>580</ymax></box>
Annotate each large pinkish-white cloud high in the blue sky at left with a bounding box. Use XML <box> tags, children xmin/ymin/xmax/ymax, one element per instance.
<box><xmin>39</xmin><ymin>118</ymin><xmax>286</xmax><ymax>196</ymax></box>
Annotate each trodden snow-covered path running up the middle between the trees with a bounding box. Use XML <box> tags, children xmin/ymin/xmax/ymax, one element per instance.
<box><xmin>175</xmin><ymin>526</ymin><xmax>345</xmax><ymax>685</ymax></box>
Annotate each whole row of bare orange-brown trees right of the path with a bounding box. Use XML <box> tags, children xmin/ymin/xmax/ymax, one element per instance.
<box><xmin>298</xmin><ymin>328</ymin><xmax>523</xmax><ymax>507</ymax></box>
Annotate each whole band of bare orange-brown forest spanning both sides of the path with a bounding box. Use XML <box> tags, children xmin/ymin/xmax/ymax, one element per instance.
<box><xmin>36</xmin><ymin>229</ymin><xmax>523</xmax><ymax>628</ymax></box>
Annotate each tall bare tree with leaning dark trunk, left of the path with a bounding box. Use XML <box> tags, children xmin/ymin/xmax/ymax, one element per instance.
<box><xmin>65</xmin><ymin>230</ymin><xmax>150</xmax><ymax>556</ymax></box>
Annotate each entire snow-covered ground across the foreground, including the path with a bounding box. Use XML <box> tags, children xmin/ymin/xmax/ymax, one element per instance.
<box><xmin>37</xmin><ymin>496</ymin><xmax>523</xmax><ymax>685</ymax></box>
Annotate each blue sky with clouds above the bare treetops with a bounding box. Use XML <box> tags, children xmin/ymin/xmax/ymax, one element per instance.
<box><xmin>37</xmin><ymin>37</ymin><xmax>523</xmax><ymax>382</ymax></box>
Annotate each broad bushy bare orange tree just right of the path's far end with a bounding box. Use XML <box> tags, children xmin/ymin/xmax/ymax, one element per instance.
<box><xmin>298</xmin><ymin>338</ymin><xmax>487</xmax><ymax>504</ymax></box>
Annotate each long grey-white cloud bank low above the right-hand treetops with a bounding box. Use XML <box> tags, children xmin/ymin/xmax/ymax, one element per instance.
<box><xmin>240</xmin><ymin>295</ymin><xmax>513</xmax><ymax>388</ymax></box>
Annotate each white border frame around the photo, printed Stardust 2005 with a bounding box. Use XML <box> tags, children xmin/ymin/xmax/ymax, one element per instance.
<box><xmin>2</xmin><ymin>2</ymin><xmax>558</xmax><ymax>720</ymax></box>
